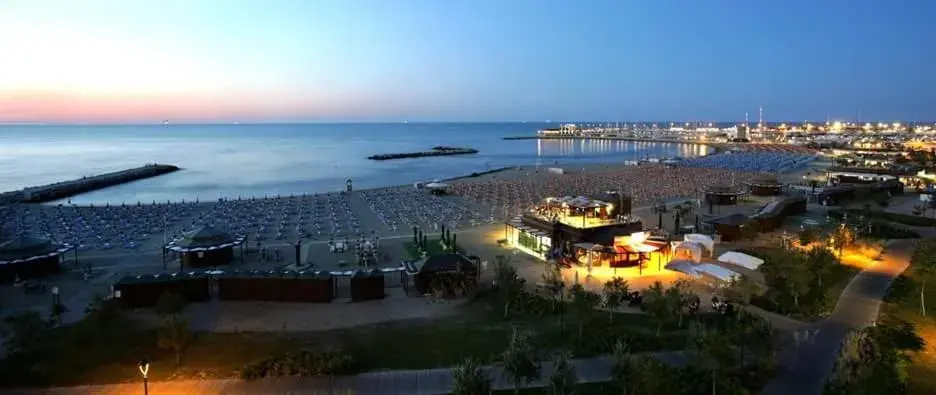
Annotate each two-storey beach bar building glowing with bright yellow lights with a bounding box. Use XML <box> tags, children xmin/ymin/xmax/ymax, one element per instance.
<box><xmin>504</xmin><ymin>193</ymin><xmax>652</xmax><ymax>267</ymax></box>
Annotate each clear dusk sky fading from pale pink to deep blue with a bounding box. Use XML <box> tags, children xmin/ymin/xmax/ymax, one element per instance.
<box><xmin>0</xmin><ymin>0</ymin><xmax>936</xmax><ymax>123</ymax></box>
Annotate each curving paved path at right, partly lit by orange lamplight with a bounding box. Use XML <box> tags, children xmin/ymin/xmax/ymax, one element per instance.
<box><xmin>761</xmin><ymin>238</ymin><xmax>920</xmax><ymax>395</ymax></box>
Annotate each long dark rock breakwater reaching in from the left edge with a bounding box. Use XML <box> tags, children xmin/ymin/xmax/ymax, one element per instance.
<box><xmin>0</xmin><ymin>164</ymin><xmax>179</xmax><ymax>203</ymax></box>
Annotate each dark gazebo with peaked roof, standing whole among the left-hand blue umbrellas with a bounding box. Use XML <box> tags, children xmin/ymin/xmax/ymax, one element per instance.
<box><xmin>164</xmin><ymin>225</ymin><xmax>246</xmax><ymax>270</ymax></box>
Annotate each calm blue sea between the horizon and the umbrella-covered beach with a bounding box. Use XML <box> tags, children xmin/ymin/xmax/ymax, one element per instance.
<box><xmin>0</xmin><ymin>123</ymin><xmax>710</xmax><ymax>204</ymax></box>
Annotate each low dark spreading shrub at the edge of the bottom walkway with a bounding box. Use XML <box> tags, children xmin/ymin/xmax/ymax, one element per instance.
<box><xmin>240</xmin><ymin>350</ymin><xmax>357</xmax><ymax>380</ymax></box>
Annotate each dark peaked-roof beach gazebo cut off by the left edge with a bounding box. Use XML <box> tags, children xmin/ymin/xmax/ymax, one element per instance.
<box><xmin>0</xmin><ymin>233</ymin><xmax>78</xmax><ymax>283</ymax></box>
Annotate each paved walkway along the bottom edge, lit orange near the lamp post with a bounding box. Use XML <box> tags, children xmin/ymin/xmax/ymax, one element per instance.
<box><xmin>0</xmin><ymin>352</ymin><xmax>685</xmax><ymax>395</ymax></box>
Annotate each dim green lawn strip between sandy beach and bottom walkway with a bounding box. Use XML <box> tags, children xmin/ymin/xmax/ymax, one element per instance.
<box><xmin>0</xmin><ymin>294</ymin><xmax>708</xmax><ymax>386</ymax></box>
